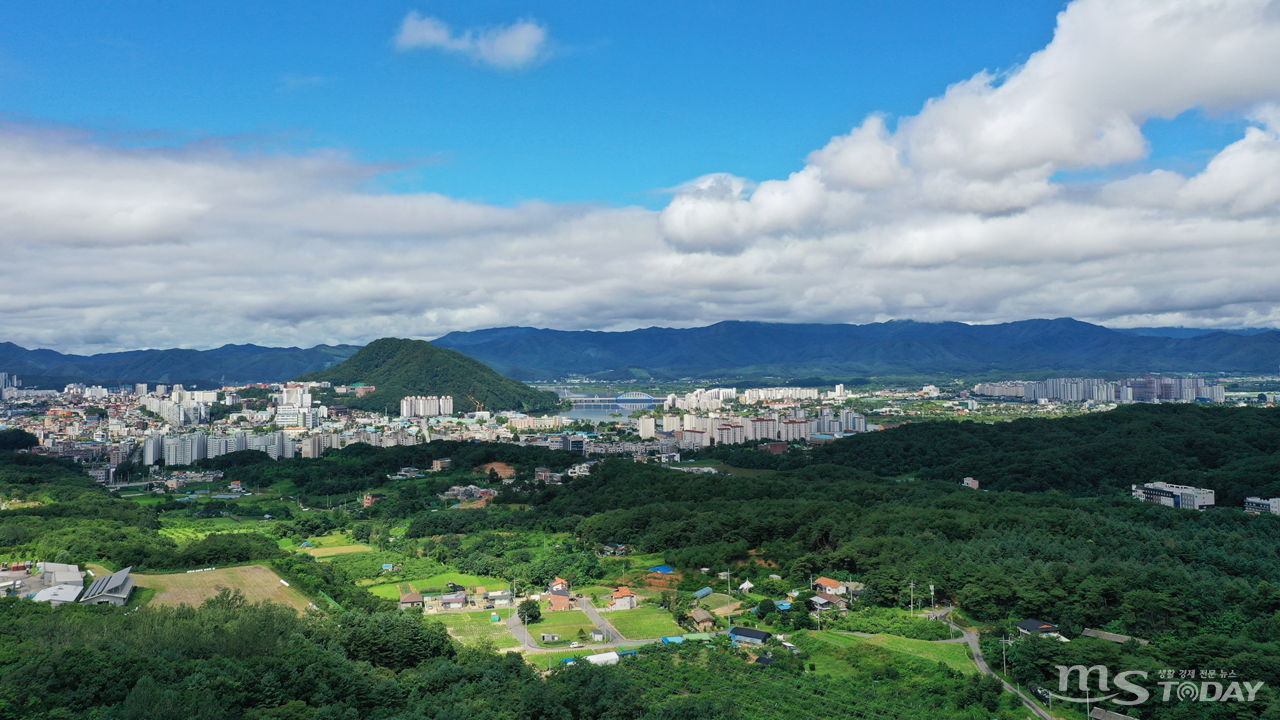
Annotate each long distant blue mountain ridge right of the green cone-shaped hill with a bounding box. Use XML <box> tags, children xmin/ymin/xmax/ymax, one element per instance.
<box><xmin>433</xmin><ymin>318</ymin><xmax>1280</xmax><ymax>379</ymax></box>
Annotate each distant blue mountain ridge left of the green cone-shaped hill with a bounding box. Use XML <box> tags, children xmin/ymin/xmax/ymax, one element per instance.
<box><xmin>0</xmin><ymin>342</ymin><xmax>360</xmax><ymax>386</ymax></box>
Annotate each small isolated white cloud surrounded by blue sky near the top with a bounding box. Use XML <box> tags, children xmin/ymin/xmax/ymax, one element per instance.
<box><xmin>396</xmin><ymin>12</ymin><xmax>548</xmax><ymax>69</ymax></box>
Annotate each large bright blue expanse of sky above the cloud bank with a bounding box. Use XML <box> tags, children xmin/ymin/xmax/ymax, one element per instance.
<box><xmin>0</xmin><ymin>0</ymin><xmax>1100</xmax><ymax>208</ymax></box>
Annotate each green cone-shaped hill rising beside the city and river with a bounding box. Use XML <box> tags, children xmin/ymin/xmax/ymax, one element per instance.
<box><xmin>298</xmin><ymin>337</ymin><xmax>558</xmax><ymax>413</ymax></box>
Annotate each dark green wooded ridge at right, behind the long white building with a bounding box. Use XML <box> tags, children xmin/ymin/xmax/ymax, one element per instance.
<box><xmin>703</xmin><ymin>405</ymin><xmax>1280</xmax><ymax>509</ymax></box>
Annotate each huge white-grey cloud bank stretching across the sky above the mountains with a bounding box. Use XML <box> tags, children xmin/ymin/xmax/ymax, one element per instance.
<box><xmin>0</xmin><ymin>0</ymin><xmax>1280</xmax><ymax>350</ymax></box>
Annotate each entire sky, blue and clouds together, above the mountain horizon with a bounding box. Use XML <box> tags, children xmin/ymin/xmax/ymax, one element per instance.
<box><xmin>0</xmin><ymin>0</ymin><xmax>1280</xmax><ymax>352</ymax></box>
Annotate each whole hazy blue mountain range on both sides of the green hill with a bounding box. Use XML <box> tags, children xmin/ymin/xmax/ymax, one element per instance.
<box><xmin>0</xmin><ymin>318</ymin><xmax>1280</xmax><ymax>386</ymax></box>
